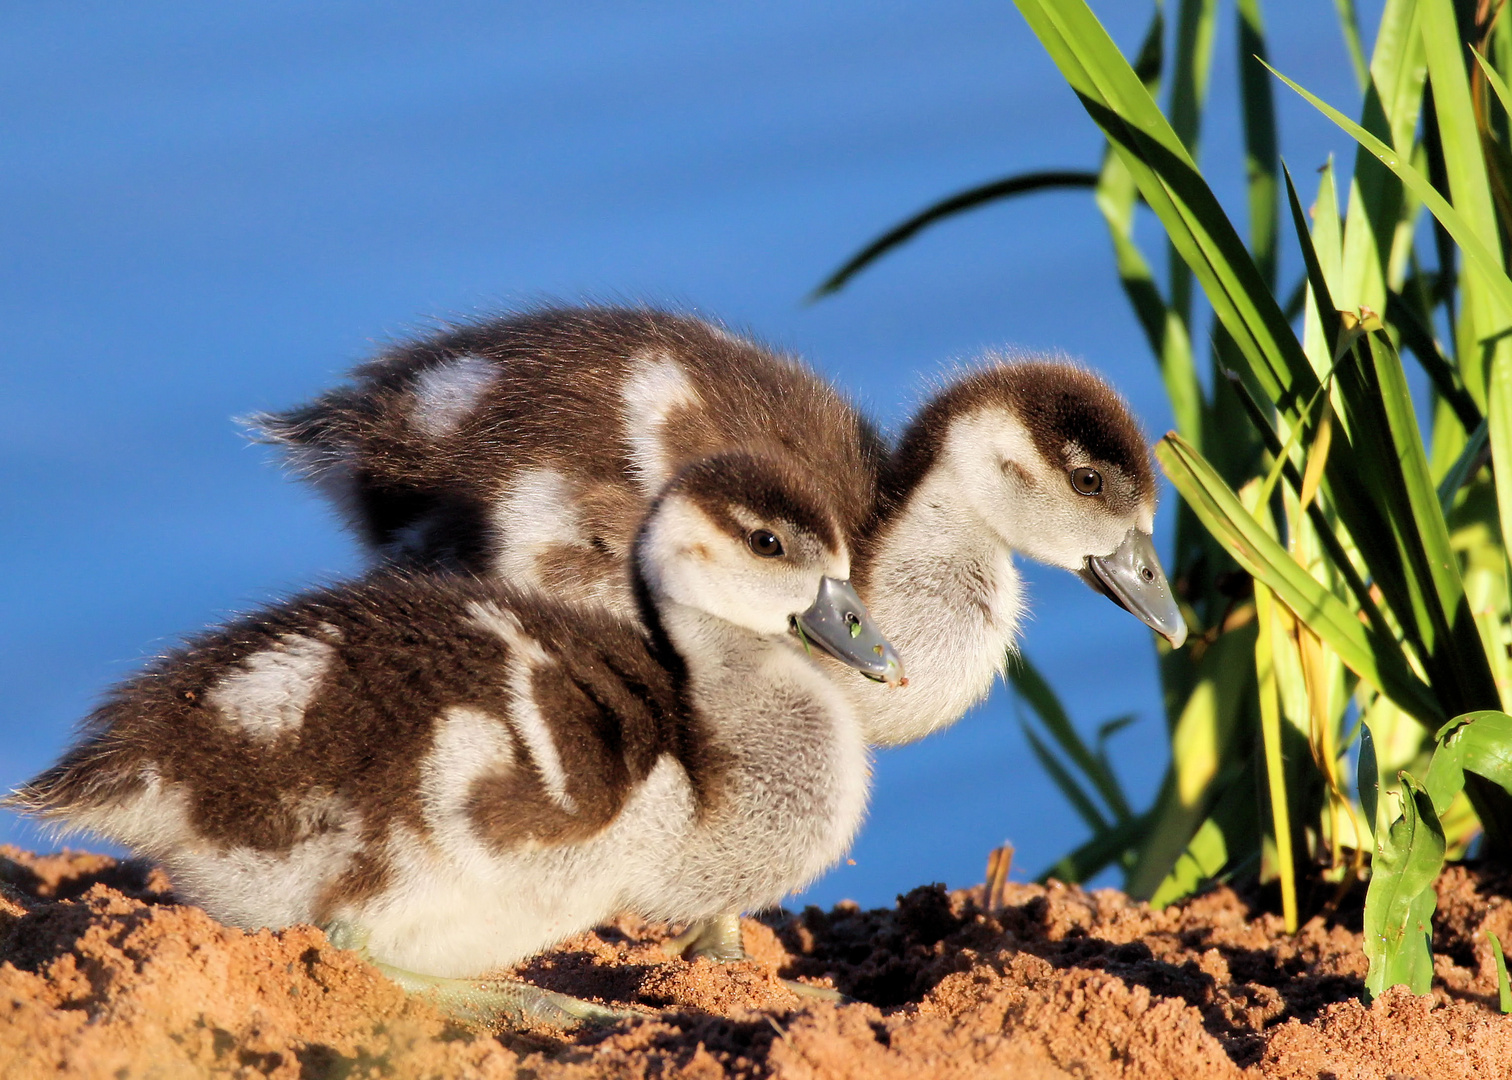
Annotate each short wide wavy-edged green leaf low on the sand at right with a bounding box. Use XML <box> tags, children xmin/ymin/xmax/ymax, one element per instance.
<box><xmin>1365</xmin><ymin>773</ymin><xmax>1445</xmax><ymax>1004</ymax></box>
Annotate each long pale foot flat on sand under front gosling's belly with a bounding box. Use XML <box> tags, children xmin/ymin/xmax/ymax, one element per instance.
<box><xmin>324</xmin><ymin>921</ymin><xmax>646</xmax><ymax>1027</ymax></box>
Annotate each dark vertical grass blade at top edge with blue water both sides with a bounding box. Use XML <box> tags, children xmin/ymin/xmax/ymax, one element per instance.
<box><xmin>1238</xmin><ymin>0</ymin><xmax>1276</xmax><ymax>290</ymax></box>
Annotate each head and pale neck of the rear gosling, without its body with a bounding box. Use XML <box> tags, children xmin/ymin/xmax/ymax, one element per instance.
<box><xmin>848</xmin><ymin>358</ymin><xmax>1187</xmax><ymax>746</ymax></box>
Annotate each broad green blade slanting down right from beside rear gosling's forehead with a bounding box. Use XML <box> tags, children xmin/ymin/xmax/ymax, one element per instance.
<box><xmin>1155</xmin><ymin>434</ymin><xmax>1444</xmax><ymax>726</ymax></box>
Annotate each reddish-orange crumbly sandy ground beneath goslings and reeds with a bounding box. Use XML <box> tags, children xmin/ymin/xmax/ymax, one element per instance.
<box><xmin>0</xmin><ymin>847</ymin><xmax>1512</xmax><ymax>1080</ymax></box>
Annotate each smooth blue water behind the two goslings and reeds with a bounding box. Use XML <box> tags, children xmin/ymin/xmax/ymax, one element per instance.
<box><xmin>0</xmin><ymin>0</ymin><xmax>1379</xmax><ymax>905</ymax></box>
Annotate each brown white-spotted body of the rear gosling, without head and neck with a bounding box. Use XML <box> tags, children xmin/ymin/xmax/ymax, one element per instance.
<box><xmin>251</xmin><ymin>307</ymin><xmax>885</xmax><ymax>617</ymax></box>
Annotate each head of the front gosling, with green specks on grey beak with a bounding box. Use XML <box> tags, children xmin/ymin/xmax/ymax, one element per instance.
<box><xmin>635</xmin><ymin>454</ymin><xmax>903</xmax><ymax>684</ymax></box>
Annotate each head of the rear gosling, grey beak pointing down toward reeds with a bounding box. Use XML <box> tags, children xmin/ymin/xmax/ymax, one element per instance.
<box><xmin>891</xmin><ymin>362</ymin><xmax>1187</xmax><ymax>647</ymax></box>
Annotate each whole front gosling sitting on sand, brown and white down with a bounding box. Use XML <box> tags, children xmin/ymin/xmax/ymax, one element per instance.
<box><xmin>9</xmin><ymin>455</ymin><xmax>901</xmax><ymax>1024</ymax></box>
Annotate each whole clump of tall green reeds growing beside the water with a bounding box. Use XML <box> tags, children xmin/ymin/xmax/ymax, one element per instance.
<box><xmin>820</xmin><ymin>0</ymin><xmax>1512</xmax><ymax>1006</ymax></box>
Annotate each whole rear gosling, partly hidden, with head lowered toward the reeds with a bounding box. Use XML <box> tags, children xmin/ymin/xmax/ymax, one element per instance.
<box><xmin>257</xmin><ymin>307</ymin><xmax>1187</xmax><ymax>746</ymax></box>
